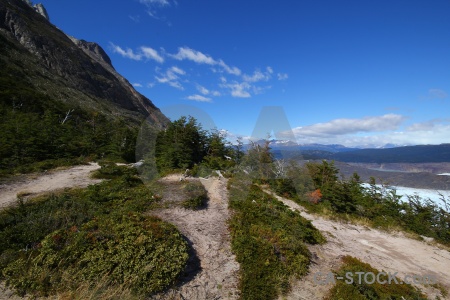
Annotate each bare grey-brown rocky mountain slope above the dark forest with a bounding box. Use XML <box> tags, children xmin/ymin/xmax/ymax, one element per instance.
<box><xmin>0</xmin><ymin>0</ymin><xmax>168</xmax><ymax>127</ymax></box>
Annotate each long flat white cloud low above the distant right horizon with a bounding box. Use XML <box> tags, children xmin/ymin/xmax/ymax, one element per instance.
<box><xmin>293</xmin><ymin>114</ymin><xmax>406</xmax><ymax>137</ymax></box>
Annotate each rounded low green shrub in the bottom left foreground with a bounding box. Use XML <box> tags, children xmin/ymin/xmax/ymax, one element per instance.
<box><xmin>3</xmin><ymin>214</ymin><xmax>188</xmax><ymax>295</ymax></box>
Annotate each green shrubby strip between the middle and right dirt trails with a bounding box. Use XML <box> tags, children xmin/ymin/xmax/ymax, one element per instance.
<box><xmin>229</xmin><ymin>178</ymin><xmax>325</xmax><ymax>299</ymax></box>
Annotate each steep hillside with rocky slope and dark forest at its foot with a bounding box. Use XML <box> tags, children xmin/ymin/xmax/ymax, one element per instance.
<box><xmin>0</xmin><ymin>0</ymin><xmax>168</xmax><ymax>172</ymax></box>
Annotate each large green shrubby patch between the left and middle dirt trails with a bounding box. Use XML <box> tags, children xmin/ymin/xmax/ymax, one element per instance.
<box><xmin>0</xmin><ymin>165</ymin><xmax>188</xmax><ymax>299</ymax></box>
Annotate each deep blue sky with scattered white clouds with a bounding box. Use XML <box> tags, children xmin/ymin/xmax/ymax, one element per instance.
<box><xmin>41</xmin><ymin>0</ymin><xmax>450</xmax><ymax>147</ymax></box>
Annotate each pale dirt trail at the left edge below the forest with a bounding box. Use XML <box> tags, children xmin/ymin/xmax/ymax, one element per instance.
<box><xmin>0</xmin><ymin>163</ymin><xmax>101</xmax><ymax>208</ymax></box>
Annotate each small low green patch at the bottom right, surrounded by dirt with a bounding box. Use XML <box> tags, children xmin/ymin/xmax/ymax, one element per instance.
<box><xmin>324</xmin><ymin>256</ymin><xmax>427</xmax><ymax>300</ymax></box>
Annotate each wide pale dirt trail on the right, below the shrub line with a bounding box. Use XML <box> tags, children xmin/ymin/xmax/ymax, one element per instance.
<box><xmin>266</xmin><ymin>191</ymin><xmax>450</xmax><ymax>300</ymax></box>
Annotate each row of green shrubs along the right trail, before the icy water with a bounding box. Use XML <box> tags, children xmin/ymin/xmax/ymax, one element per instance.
<box><xmin>301</xmin><ymin>161</ymin><xmax>450</xmax><ymax>245</ymax></box>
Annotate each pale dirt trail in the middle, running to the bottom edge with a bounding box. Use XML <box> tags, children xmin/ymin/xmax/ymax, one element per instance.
<box><xmin>152</xmin><ymin>176</ymin><xmax>239</xmax><ymax>299</ymax></box>
